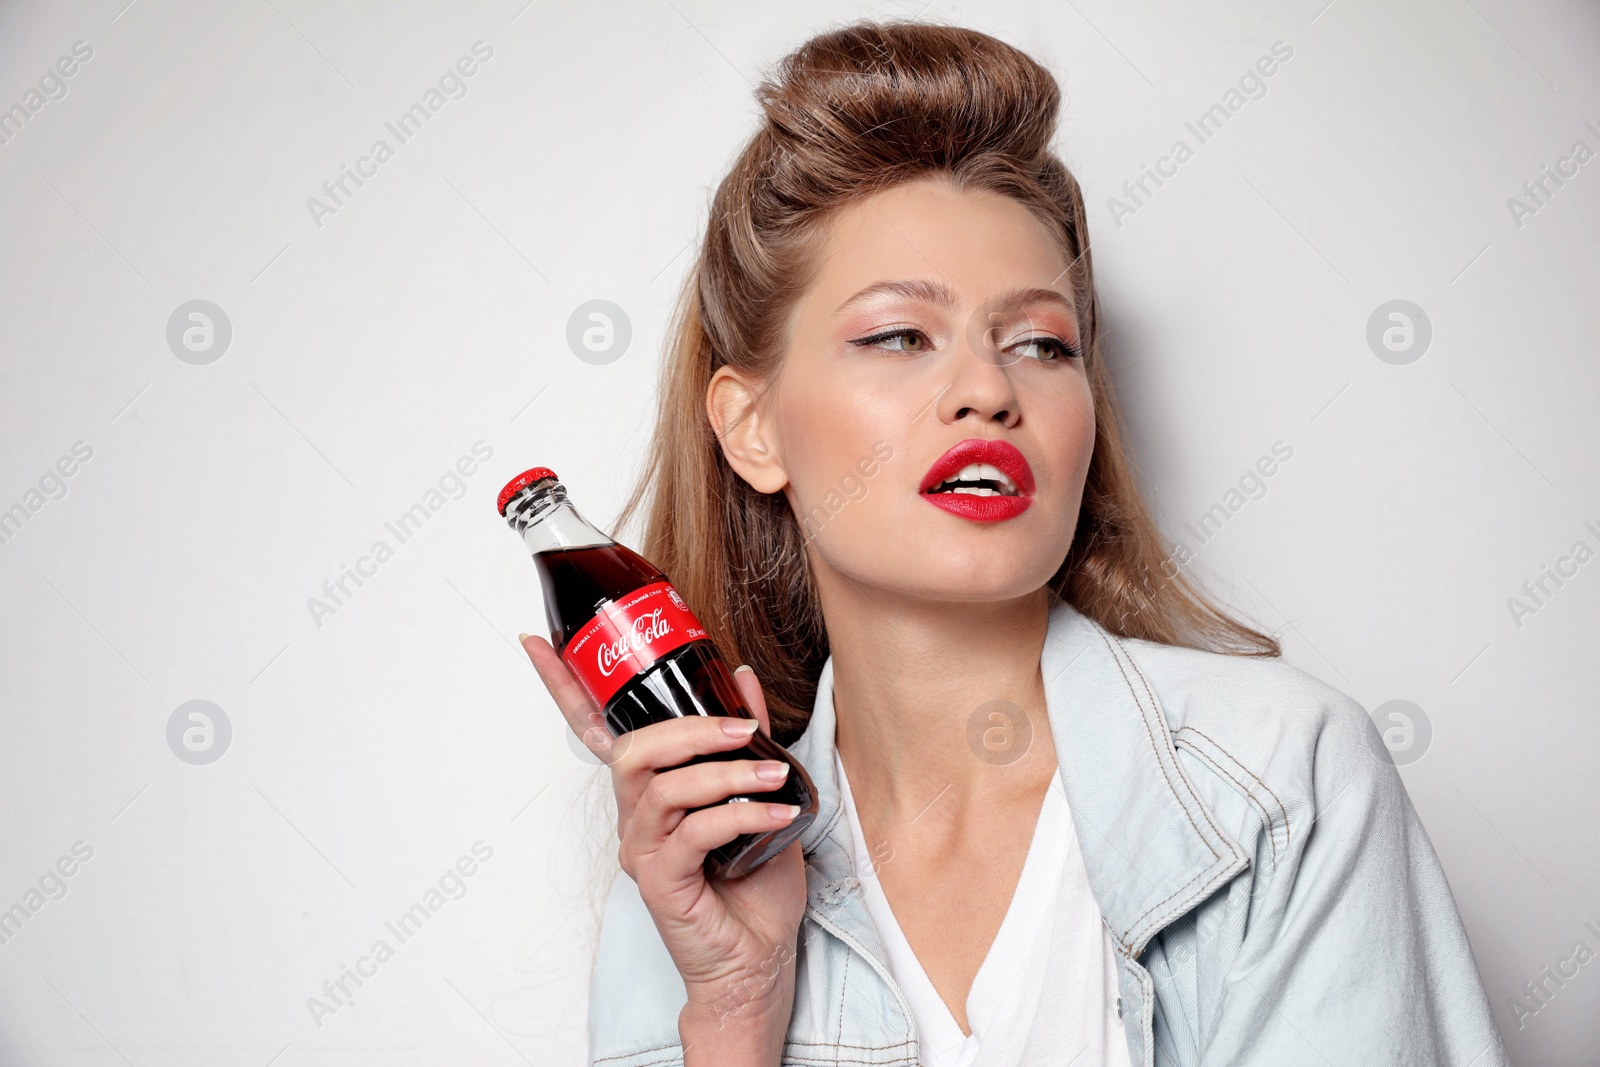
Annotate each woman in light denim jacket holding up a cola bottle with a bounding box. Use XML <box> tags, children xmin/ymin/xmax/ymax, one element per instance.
<box><xmin>523</xmin><ymin>24</ymin><xmax>1506</xmax><ymax>1067</ymax></box>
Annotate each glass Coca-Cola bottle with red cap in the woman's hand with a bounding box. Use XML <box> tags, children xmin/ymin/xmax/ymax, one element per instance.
<box><xmin>499</xmin><ymin>467</ymin><xmax>818</xmax><ymax>878</ymax></box>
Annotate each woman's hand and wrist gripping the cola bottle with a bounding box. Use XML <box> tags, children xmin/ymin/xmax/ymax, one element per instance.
<box><xmin>522</xmin><ymin>635</ymin><xmax>806</xmax><ymax>1064</ymax></box>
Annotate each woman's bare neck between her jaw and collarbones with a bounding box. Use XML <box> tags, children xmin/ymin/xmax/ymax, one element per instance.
<box><xmin>813</xmin><ymin>563</ymin><xmax>1056</xmax><ymax>824</ymax></box>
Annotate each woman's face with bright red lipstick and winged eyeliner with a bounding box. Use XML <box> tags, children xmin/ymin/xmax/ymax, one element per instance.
<box><xmin>723</xmin><ymin>179</ymin><xmax>1094</xmax><ymax>600</ymax></box>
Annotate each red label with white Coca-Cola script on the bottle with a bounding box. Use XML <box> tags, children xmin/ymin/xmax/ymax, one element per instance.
<box><xmin>562</xmin><ymin>582</ymin><xmax>710</xmax><ymax>709</ymax></box>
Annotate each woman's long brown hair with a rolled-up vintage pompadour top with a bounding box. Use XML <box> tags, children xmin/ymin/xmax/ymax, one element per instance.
<box><xmin>618</xmin><ymin>22</ymin><xmax>1278</xmax><ymax>742</ymax></box>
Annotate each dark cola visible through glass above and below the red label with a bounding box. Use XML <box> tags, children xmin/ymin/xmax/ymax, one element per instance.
<box><xmin>533</xmin><ymin>544</ymin><xmax>818</xmax><ymax>877</ymax></box>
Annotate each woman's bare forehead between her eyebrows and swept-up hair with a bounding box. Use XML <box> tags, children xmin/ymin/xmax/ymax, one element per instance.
<box><xmin>814</xmin><ymin>178</ymin><xmax>1070</xmax><ymax>300</ymax></box>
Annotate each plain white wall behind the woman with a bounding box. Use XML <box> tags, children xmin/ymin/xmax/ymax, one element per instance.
<box><xmin>0</xmin><ymin>0</ymin><xmax>1600</xmax><ymax>1067</ymax></box>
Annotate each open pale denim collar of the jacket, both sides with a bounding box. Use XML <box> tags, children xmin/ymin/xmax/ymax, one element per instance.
<box><xmin>790</xmin><ymin>601</ymin><xmax>1250</xmax><ymax>971</ymax></box>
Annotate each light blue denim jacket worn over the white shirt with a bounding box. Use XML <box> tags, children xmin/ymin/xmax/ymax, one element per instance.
<box><xmin>589</xmin><ymin>603</ymin><xmax>1509</xmax><ymax>1067</ymax></box>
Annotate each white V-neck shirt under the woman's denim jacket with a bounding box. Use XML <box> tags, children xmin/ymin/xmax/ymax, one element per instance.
<box><xmin>834</xmin><ymin>752</ymin><xmax>1130</xmax><ymax>1067</ymax></box>
